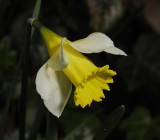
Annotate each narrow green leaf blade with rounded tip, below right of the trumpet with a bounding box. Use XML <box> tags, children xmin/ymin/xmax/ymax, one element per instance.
<box><xmin>93</xmin><ymin>105</ymin><xmax>125</xmax><ymax>140</ymax></box>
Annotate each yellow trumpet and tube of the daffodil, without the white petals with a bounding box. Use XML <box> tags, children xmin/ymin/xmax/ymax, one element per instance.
<box><xmin>40</xmin><ymin>27</ymin><xmax>116</xmax><ymax>108</ymax></box>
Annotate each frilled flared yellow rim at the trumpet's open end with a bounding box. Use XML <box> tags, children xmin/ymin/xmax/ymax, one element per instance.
<box><xmin>74</xmin><ymin>65</ymin><xmax>116</xmax><ymax>108</ymax></box>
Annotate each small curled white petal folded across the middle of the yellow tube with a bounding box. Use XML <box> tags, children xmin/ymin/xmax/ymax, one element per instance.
<box><xmin>48</xmin><ymin>38</ymin><xmax>69</xmax><ymax>71</ymax></box>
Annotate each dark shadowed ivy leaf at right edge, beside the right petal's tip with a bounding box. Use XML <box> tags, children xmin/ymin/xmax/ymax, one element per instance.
<box><xmin>118</xmin><ymin>35</ymin><xmax>160</xmax><ymax>90</ymax></box>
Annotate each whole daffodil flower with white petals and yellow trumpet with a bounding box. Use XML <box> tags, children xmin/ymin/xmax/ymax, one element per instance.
<box><xmin>30</xmin><ymin>19</ymin><xmax>126</xmax><ymax>117</ymax></box>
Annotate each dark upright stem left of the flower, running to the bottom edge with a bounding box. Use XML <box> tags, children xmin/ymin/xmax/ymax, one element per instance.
<box><xmin>19</xmin><ymin>25</ymin><xmax>31</xmax><ymax>140</ymax></box>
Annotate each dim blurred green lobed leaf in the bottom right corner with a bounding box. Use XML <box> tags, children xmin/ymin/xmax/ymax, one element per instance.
<box><xmin>120</xmin><ymin>107</ymin><xmax>160</xmax><ymax>140</ymax></box>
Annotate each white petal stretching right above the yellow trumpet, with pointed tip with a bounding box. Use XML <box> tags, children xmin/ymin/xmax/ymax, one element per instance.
<box><xmin>69</xmin><ymin>32</ymin><xmax>126</xmax><ymax>55</ymax></box>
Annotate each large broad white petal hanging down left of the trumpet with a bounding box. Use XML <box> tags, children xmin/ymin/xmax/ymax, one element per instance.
<box><xmin>36</xmin><ymin>63</ymin><xmax>72</xmax><ymax>117</ymax></box>
